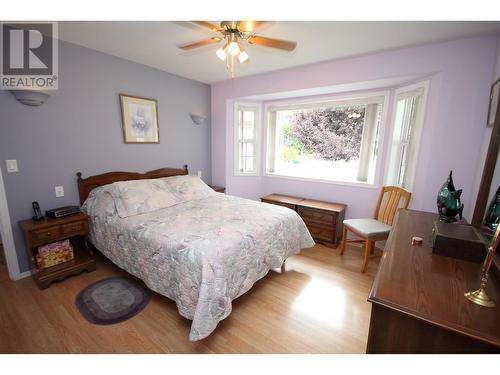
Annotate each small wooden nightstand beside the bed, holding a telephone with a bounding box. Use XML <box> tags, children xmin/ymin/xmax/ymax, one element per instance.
<box><xmin>19</xmin><ymin>213</ymin><xmax>96</xmax><ymax>289</ymax></box>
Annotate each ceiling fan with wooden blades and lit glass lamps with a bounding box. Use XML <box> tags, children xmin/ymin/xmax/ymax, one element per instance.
<box><xmin>179</xmin><ymin>21</ymin><xmax>297</xmax><ymax>78</ymax></box>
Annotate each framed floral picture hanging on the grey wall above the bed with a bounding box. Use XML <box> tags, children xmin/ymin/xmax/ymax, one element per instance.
<box><xmin>120</xmin><ymin>94</ymin><xmax>160</xmax><ymax>143</ymax></box>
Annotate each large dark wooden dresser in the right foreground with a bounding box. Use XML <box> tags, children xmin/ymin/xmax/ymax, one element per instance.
<box><xmin>366</xmin><ymin>209</ymin><xmax>500</xmax><ymax>353</ymax></box>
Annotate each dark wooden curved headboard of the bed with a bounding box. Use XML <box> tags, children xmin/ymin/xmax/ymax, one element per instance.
<box><xmin>76</xmin><ymin>165</ymin><xmax>188</xmax><ymax>204</ymax></box>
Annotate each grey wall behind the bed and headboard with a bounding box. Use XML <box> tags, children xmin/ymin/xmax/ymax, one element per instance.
<box><xmin>0</xmin><ymin>42</ymin><xmax>211</xmax><ymax>272</ymax></box>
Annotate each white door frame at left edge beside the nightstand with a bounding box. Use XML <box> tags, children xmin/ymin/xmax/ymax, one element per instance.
<box><xmin>0</xmin><ymin>168</ymin><xmax>23</xmax><ymax>280</ymax></box>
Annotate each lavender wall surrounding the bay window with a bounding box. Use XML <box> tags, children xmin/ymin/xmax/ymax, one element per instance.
<box><xmin>212</xmin><ymin>35</ymin><xmax>497</xmax><ymax>222</ymax></box>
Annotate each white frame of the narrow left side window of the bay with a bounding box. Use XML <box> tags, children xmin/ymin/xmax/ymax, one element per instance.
<box><xmin>233</xmin><ymin>102</ymin><xmax>262</xmax><ymax>177</ymax></box>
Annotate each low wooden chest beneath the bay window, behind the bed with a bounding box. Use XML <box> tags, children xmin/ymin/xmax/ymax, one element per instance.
<box><xmin>261</xmin><ymin>194</ymin><xmax>347</xmax><ymax>247</ymax></box>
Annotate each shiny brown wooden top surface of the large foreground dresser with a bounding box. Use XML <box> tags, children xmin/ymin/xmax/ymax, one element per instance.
<box><xmin>368</xmin><ymin>209</ymin><xmax>500</xmax><ymax>347</ymax></box>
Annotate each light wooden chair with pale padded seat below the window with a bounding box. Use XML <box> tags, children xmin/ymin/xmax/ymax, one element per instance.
<box><xmin>340</xmin><ymin>186</ymin><xmax>411</xmax><ymax>273</ymax></box>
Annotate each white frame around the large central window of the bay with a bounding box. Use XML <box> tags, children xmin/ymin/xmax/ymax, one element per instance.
<box><xmin>261</xmin><ymin>90</ymin><xmax>391</xmax><ymax>189</ymax></box>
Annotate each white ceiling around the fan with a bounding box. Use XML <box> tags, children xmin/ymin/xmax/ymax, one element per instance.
<box><xmin>59</xmin><ymin>21</ymin><xmax>500</xmax><ymax>83</ymax></box>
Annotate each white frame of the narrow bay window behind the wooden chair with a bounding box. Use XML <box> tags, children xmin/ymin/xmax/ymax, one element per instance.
<box><xmin>384</xmin><ymin>79</ymin><xmax>430</xmax><ymax>191</ymax></box>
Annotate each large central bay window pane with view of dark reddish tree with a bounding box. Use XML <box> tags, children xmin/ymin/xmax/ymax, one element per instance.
<box><xmin>266</xmin><ymin>95</ymin><xmax>385</xmax><ymax>184</ymax></box>
